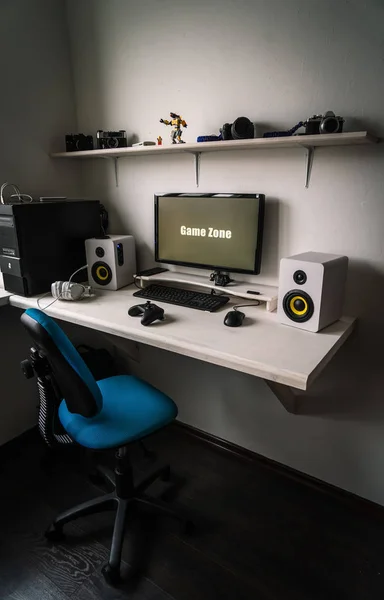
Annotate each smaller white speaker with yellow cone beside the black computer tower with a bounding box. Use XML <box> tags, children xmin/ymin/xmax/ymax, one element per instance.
<box><xmin>85</xmin><ymin>235</ymin><xmax>136</xmax><ymax>290</ymax></box>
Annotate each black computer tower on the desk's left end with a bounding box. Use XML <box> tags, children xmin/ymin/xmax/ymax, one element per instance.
<box><xmin>0</xmin><ymin>200</ymin><xmax>102</xmax><ymax>296</ymax></box>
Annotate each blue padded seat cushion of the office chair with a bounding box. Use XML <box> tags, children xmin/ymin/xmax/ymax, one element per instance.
<box><xmin>59</xmin><ymin>375</ymin><xmax>177</xmax><ymax>450</ymax></box>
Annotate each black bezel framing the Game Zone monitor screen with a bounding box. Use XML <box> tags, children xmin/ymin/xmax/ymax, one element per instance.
<box><xmin>154</xmin><ymin>192</ymin><xmax>265</xmax><ymax>275</ymax></box>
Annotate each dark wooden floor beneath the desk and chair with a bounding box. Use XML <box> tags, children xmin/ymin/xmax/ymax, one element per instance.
<box><xmin>0</xmin><ymin>428</ymin><xmax>384</xmax><ymax>600</ymax></box>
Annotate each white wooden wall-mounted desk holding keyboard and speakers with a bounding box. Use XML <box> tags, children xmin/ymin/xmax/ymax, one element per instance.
<box><xmin>9</xmin><ymin>286</ymin><xmax>355</xmax><ymax>412</ymax></box>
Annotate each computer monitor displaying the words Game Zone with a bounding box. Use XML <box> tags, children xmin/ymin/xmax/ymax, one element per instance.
<box><xmin>155</xmin><ymin>194</ymin><xmax>265</xmax><ymax>273</ymax></box>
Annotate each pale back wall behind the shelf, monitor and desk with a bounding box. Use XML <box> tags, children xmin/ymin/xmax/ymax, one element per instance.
<box><xmin>68</xmin><ymin>0</ymin><xmax>384</xmax><ymax>504</ymax></box>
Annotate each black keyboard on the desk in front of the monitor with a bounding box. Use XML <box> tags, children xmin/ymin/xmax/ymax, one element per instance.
<box><xmin>133</xmin><ymin>283</ymin><xmax>229</xmax><ymax>312</ymax></box>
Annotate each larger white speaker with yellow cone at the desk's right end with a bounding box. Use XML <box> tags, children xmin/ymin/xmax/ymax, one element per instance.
<box><xmin>277</xmin><ymin>252</ymin><xmax>348</xmax><ymax>331</ymax></box>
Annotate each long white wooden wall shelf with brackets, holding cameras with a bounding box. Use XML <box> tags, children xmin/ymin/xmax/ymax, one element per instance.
<box><xmin>51</xmin><ymin>131</ymin><xmax>379</xmax><ymax>187</ymax></box>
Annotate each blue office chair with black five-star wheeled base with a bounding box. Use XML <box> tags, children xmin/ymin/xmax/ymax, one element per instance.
<box><xmin>21</xmin><ymin>308</ymin><xmax>192</xmax><ymax>585</ymax></box>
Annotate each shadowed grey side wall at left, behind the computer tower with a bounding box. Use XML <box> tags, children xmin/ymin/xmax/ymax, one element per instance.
<box><xmin>0</xmin><ymin>0</ymin><xmax>81</xmax><ymax>444</ymax></box>
